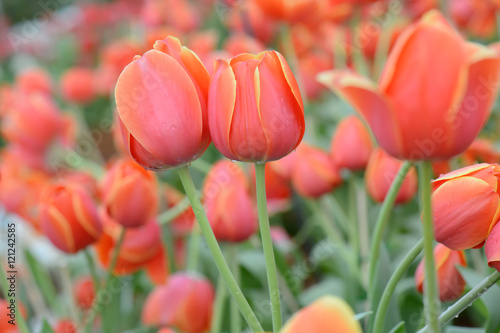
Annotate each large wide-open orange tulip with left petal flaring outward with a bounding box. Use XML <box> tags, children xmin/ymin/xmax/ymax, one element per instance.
<box><xmin>319</xmin><ymin>11</ymin><xmax>500</xmax><ymax>160</ymax></box>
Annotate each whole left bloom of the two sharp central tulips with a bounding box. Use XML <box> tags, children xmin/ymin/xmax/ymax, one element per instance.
<box><xmin>115</xmin><ymin>37</ymin><xmax>210</xmax><ymax>169</ymax></box>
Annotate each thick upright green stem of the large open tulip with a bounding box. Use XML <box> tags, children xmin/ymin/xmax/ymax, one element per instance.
<box><xmin>419</xmin><ymin>160</ymin><xmax>441</xmax><ymax>333</ymax></box>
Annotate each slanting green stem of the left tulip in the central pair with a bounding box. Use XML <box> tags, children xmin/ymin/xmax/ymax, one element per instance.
<box><xmin>178</xmin><ymin>166</ymin><xmax>264</xmax><ymax>332</ymax></box>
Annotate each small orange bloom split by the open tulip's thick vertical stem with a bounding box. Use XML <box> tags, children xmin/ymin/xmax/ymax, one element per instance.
<box><xmin>415</xmin><ymin>244</ymin><xmax>467</xmax><ymax>302</ymax></box>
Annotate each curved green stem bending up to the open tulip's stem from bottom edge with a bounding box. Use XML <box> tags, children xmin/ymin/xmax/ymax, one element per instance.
<box><xmin>372</xmin><ymin>240</ymin><xmax>424</xmax><ymax>333</ymax></box>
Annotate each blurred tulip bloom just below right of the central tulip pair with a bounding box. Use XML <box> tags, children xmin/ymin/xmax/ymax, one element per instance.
<box><xmin>292</xmin><ymin>144</ymin><xmax>342</xmax><ymax>198</ymax></box>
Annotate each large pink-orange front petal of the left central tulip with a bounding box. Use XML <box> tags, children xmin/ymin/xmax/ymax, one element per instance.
<box><xmin>115</xmin><ymin>50</ymin><xmax>203</xmax><ymax>165</ymax></box>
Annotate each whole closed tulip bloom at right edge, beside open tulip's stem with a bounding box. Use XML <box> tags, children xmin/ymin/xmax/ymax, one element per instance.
<box><xmin>432</xmin><ymin>163</ymin><xmax>500</xmax><ymax>250</ymax></box>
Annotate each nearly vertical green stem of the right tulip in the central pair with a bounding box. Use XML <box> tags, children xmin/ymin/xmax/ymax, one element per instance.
<box><xmin>255</xmin><ymin>163</ymin><xmax>282</xmax><ymax>332</ymax></box>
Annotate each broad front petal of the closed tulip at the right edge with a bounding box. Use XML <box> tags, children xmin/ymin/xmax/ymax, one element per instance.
<box><xmin>432</xmin><ymin>177</ymin><xmax>500</xmax><ymax>250</ymax></box>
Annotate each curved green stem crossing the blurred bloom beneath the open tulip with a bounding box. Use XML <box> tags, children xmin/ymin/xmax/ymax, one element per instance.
<box><xmin>369</xmin><ymin>161</ymin><xmax>412</xmax><ymax>294</ymax></box>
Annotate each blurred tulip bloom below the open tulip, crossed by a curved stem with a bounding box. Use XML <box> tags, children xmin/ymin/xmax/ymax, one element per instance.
<box><xmin>365</xmin><ymin>148</ymin><xmax>417</xmax><ymax>204</ymax></box>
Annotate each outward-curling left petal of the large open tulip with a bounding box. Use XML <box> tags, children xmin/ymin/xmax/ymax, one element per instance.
<box><xmin>318</xmin><ymin>70</ymin><xmax>402</xmax><ymax>157</ymax></box>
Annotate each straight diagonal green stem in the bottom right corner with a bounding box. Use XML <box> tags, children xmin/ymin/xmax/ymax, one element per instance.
<box><xmin>418</xmin><ymin>271</ymin><xmax>500</xmax><ymax>333</ymax></box>
